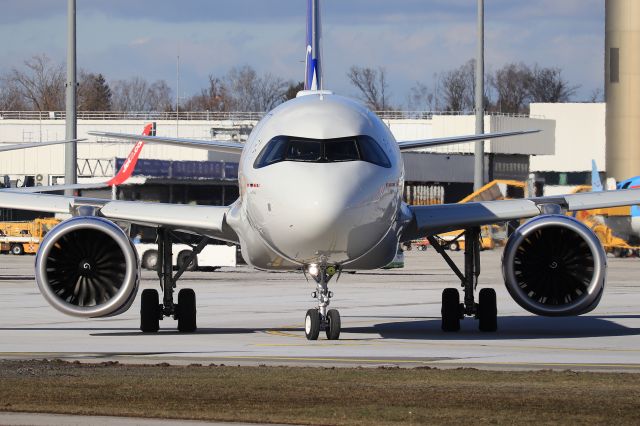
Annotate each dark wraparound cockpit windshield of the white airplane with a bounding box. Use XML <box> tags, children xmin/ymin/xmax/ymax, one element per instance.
<box><xmin>253</xmin><ymin>135</ymin><xmax>391</xmax><ymax>169</ymax></box>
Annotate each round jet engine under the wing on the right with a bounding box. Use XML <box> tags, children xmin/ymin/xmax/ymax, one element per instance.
<box><xmin>502</xmin><ymin>215</ymin><xmax>607</xmax><ymax>316</ymax></box>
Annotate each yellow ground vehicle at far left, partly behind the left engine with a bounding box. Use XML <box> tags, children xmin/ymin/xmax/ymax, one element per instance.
<box><xmin>0</xmin><ymin>218</ymin><xmax>60</xmax><ymax>255</ymax></box>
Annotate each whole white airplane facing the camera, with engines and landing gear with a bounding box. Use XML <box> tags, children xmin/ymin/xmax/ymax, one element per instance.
<box><xmin>0</xmin><ymin>0</ymin><xmax>640</xmax><ymax>340</ymax></box>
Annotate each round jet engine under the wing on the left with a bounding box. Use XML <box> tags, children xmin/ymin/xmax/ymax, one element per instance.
<box><xmin>35</xmin><ymin>216</ymin><xmax>140</xmax><ymax>318</ymax></box>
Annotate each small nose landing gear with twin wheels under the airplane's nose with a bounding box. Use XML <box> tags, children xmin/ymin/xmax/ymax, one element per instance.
<box><xmin>304</xmin><ymin>265</ymin><xmax>341</xmax><ymax>340</ymax></box>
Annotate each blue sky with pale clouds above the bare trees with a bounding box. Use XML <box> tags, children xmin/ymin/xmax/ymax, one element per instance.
<box><xmin>0</xmin><ymin>0</ymin><xmax>604</xmax><ymax>106</ymax></box>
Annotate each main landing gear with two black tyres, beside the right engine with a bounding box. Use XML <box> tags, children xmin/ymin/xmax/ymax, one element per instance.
<box><xmin>428</xmin><ymin>228</ymin><xmax>498</xmax><ymax>331</ymax></box>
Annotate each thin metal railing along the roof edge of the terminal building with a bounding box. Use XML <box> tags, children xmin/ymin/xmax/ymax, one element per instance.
<box><xmin>0</xmin><ymin>111</ymin><xmax>530</xmax><ymax>121</ymax></box>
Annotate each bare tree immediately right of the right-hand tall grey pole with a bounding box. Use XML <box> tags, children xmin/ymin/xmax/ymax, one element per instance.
<box><xmin>489</xmin><ymin>63</ymin><xmax>532</xmax><ymax>113</ymax></box>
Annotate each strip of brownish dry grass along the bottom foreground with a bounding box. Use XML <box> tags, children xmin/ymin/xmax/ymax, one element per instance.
<box><xmin>0</xmin><ymin>361</ymin><xmax>640</xmax><ymax>425</ymax></box>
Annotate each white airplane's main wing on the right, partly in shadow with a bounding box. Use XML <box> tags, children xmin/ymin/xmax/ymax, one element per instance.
<box><xmin>402</xmin><ymin>189</ymin><xmax>640</xmax><ymax>241</ymax></box>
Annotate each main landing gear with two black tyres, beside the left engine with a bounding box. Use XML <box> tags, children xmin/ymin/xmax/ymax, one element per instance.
<box><xmin>140</xmin><ymin>228</ymin><xmax>208</xmax><ymax>333</ymax></box>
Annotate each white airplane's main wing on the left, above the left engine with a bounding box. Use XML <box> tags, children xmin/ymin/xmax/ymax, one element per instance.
<box><xmin>0</xmin><ymin>191</ymin><xmax>238</xmax><ymax>242</ymax></box>
